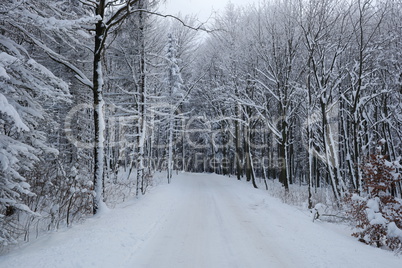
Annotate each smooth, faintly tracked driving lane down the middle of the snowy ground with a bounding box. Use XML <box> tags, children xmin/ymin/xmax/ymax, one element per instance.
<box><xmin>135</xmin><ymin>175</ymin><xmax>292</xmax><ymax>267</ymax></box>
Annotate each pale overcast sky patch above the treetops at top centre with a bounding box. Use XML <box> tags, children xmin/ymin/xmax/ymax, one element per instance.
<box><xmin>160</xmin><ymin>0</ymin><xmax>254</xmax><ymax>22</ymax></box>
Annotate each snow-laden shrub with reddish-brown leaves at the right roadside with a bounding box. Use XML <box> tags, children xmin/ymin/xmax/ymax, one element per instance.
<box><xmin>347</xmin><ymin>154</ymin><xmax>402</xmax><ymax>250</ymax></box>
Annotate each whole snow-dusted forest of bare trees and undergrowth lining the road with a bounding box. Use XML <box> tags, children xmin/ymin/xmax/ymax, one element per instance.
<box><xmin>0</xmin><ymin>0</ymin><xmax>402</xmax><ymax>249</ymax></box>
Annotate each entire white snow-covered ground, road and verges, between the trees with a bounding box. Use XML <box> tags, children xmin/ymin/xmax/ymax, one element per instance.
<box><xmin>0</xmin><ymin>174</ymin><xmax>402</xmax><ymax>268</ymax></box>
